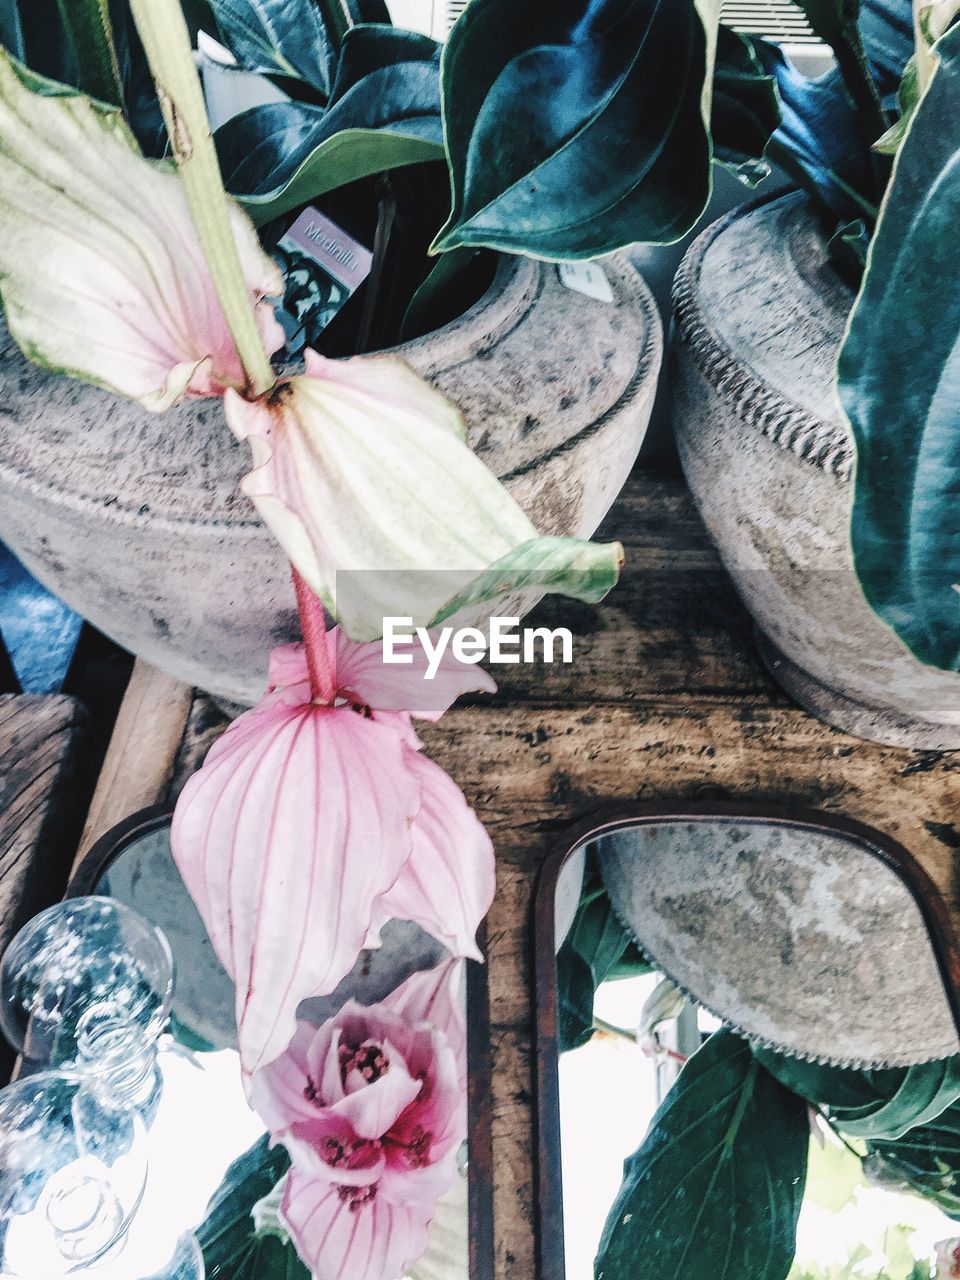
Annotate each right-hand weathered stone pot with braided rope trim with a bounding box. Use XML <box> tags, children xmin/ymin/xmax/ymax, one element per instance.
<box><xmin>672</xmin><ymin>193</ymin><xmax>960</xmax><ymax>750</ymax></box>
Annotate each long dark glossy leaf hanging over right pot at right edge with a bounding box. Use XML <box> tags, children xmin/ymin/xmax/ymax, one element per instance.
<box><xmin>838</xmin><ymin>20</ymin><xmax>960</xmax><ymax>671</ymax></box>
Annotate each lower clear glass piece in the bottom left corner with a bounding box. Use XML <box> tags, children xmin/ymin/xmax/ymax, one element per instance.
<box><xmin>0</xmin><ymin>1071</ymin><xmax>147</xmax><ymax>1280</ymax></box>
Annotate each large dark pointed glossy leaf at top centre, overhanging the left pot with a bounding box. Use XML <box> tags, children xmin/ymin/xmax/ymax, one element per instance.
<box><xmin>435</xmin><ymin>0</ymin><xmax>721</xmax><ymax>259</ymax></box>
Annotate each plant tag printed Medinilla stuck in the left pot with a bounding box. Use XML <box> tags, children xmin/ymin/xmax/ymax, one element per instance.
<box><xmin>275</xmin><ymin>206</ymin><xmax>374</xmax><ymax>356</ymax></box>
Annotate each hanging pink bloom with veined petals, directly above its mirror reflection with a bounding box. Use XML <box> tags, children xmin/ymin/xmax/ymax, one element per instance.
<box><xmin>172</xmin><ymin>591</ymin><xmax>495</xmax><ymax>1075</ymax></box>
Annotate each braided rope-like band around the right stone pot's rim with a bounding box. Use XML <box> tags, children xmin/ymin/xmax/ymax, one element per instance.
<box><xmin>673</xmin><ymin>191</ymin><xmax>855</xmax><ymax>481</ymax></box>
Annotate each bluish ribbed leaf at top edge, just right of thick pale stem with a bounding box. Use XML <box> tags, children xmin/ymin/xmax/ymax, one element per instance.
<box><xmin>210</xmin><ymin>0</ymin><xmax>337</xmax><ymax>97</ymax></box>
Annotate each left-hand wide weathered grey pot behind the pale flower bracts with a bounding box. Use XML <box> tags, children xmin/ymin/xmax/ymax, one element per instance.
<box><xmin>0</xmin><ymin>259</ymin><xmax>662</xmax><ymax>703</ymax></box>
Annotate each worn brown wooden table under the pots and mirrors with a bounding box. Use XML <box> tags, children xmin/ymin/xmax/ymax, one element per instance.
<box><xmin>67</xmin><ymin>471</ymin><xmax>960</xmax><ymax>1280</ymax></box>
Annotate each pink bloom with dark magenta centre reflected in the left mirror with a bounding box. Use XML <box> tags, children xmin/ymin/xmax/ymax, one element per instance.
<box><xmin>251</xmin><ymin>960</ymin><xmax>467</xmax><ymax>1280</ymax></box>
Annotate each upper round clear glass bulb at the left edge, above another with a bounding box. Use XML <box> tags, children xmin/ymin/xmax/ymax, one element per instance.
<box><xmin>0</xmin><ymin>896</ymin><xmax>173</xmax><ymax>1073</ymax></box>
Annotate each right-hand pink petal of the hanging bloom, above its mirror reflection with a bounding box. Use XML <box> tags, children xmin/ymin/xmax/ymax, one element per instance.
<box><xmin>379</xmin><ymin>749</ymin><xmax>497</xmax><ymax>960</ymax></box>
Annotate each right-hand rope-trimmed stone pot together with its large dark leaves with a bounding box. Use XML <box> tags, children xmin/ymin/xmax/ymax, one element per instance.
<box><xmin>440</xmin><ymin>0</ymin><xmax>960</xmax><ymax>749</ymax></box>
